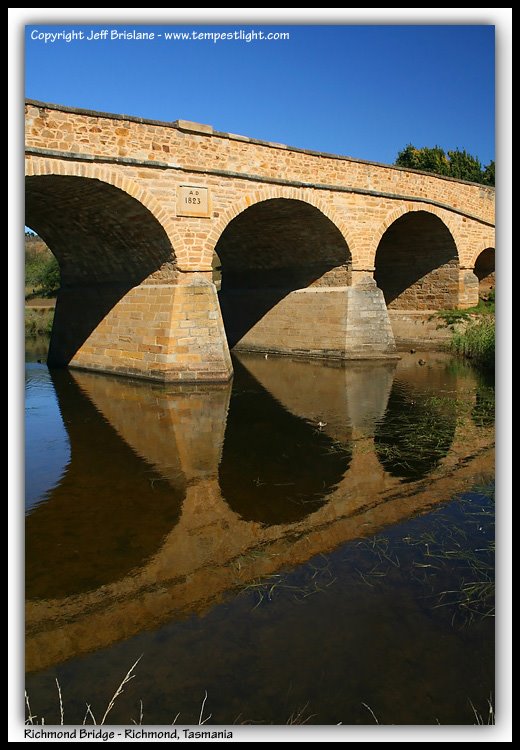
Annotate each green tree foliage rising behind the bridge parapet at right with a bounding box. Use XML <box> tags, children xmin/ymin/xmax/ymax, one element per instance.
<box><xmin>395</xmin><ymin>143</ymin><xmax>495</xmax><ymax>185</ymax></box>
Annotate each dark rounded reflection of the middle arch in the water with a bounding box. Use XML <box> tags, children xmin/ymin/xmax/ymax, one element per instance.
<box><xmin>219</xmin><ymin>359</ymin><xmax>352</xmax><ymax>525</ymax></box>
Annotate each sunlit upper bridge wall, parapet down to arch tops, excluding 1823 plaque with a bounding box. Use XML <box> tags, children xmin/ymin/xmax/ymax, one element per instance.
<box><xmin>26</xmin><ymin>102</ymin><xmax>494</xmax><ymax>271</ymax></box>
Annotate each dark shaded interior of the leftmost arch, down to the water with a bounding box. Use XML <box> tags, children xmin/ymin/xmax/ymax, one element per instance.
<box><xmin>25</xmin><ymin>174</ymin><xmax>175</xmax><ymax>365</ymax></box>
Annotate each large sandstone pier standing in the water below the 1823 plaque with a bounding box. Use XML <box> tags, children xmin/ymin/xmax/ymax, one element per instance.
<box><xmin>54</xmin><ymin>278</ymin><xmax>232</xmax><ymax>382</ymax></box>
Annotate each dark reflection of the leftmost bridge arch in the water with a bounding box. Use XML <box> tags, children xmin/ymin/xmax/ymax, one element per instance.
<box><xmin>25</xmin><ymin>370</ymin><xmax>185</xmax><ymax>599</ymax></box>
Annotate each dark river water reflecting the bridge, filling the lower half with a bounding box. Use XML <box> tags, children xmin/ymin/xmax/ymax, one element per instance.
<box><xmin>26</xmin><ymin>350</ymin><xmax>494</xmax><ymax>724</ymax></box>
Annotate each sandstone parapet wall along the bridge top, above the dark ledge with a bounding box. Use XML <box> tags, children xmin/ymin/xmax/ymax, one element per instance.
<box><xmin>26</xmin><ymin>101</ymin><xmax>494</xmax><ymax>226</ymax></box>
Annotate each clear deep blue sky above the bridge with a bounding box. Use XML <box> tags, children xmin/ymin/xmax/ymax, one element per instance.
<box><xmin>25</xmin><ymin>24</ymin><xmax>495</xmax><ymax>169</ymax></box>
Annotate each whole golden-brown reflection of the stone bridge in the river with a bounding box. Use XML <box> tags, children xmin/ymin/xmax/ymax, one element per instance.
<box><xmin>26</xmin><ymin>354</ymin><xmax>493</xmax><ymax>671</ymax></box>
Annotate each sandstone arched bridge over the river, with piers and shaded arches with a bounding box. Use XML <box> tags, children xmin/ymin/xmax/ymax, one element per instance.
<box><xmin>25</xmin><ymin>101</ymin><xmax>495</xmax><ymax>381</ymax></box>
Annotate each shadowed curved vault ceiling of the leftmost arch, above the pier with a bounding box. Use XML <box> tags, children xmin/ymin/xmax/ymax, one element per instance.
<box><xmin>25</xmin><ymin>172</ymin><xmax>174</xmax><ymax>286</ymax></box>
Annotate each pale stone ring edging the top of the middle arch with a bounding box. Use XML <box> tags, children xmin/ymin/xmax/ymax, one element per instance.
<box><xmin>204</xmin><ymin>185</ymin><xmax>358</xmax><ymax>268</ymax></box>
